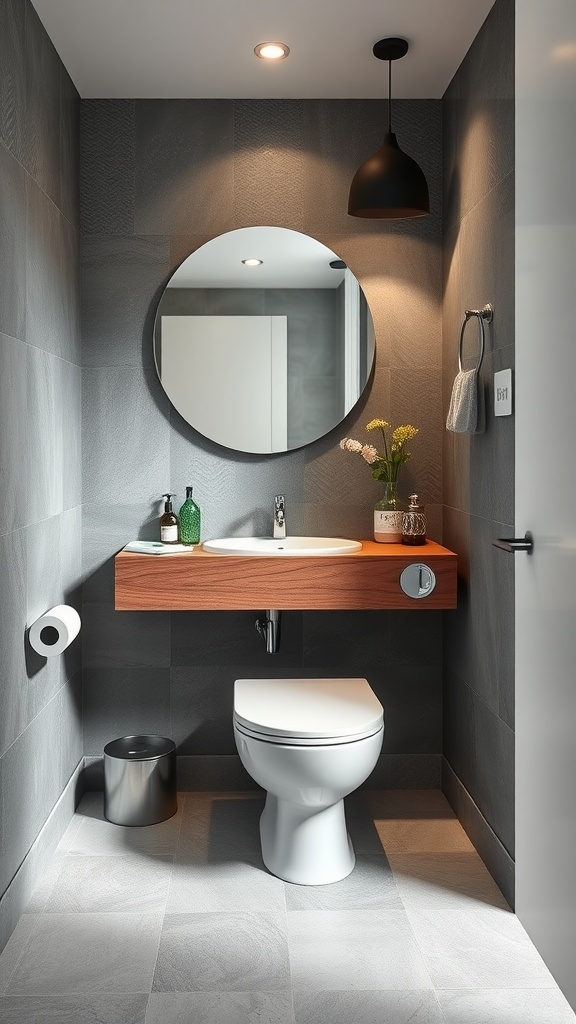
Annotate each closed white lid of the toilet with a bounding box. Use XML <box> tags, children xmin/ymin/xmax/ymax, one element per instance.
<box><xmin>234</xmin><ymin>679</ymin><xmax>383</xmax><ymax>742</ymax></box>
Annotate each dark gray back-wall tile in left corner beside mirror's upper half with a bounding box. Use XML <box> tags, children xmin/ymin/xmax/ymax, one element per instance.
<box><xmin>82</xmin><ymin>234</ymin><xmax>169</xmax><ymax>367</ymax></box>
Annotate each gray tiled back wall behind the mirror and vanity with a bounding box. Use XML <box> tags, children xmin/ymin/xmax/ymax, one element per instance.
<box><xmin>81</xmin><ymin>100</ymin><xmax>443</xmax><ymax>785</ymax></box>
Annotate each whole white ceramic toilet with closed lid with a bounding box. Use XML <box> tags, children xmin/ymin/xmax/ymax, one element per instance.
<box><xmin>234</xmin><ymin>679</ymin><xmax>384</xmax><ymax>886</ymax></box>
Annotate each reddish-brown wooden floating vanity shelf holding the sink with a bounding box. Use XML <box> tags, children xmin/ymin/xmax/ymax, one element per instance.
<box><xmin>115</xmin><ymin>541</ymin><xmax>457</xmax><ymax>611</ymax></box>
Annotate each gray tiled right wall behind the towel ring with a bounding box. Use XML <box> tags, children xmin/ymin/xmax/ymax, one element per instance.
<box><xmin>436</xmin><ymin>0</ymin><xmax>515</xmax><ymax>891</ymax></box>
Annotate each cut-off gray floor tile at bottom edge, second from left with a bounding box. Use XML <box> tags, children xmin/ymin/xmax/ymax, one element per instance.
<box><xmin>146</xmin><ymin>992</ymin><xmax>294</xmax><ymax>1024</ymax></box>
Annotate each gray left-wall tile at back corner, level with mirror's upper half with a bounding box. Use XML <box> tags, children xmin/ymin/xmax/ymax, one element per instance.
<box><xmin>26</xmin><ymin>178</ymin><xmax>80</xmax><ymax>365</ymax></box>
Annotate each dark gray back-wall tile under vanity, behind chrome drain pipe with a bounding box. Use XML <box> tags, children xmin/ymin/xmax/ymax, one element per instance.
<box><xmin>171</xmin><ymin>608</ymin><xmax>302</xmax><ymax>674</ymax></box>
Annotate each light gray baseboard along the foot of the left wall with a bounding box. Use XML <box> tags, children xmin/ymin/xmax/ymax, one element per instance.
<box><xmin>0</xmin><ymin>759</ymin><xmax>84</xmax><ymax>952</ymax></box>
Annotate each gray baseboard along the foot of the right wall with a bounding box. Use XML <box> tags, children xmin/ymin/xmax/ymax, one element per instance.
<box><xmin>442</xmin><ymin>758</ymin><xmax>516</xmax><ymax>910</ymax></box>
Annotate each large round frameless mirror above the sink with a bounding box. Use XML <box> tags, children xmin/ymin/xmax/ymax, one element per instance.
<box><xmin>154</xmin><ymin>227</ymin><xmax>374</xmax><ymax>454</ymax></box>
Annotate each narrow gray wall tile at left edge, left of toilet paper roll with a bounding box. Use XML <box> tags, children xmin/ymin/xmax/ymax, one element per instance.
<box><xmin>0</xmin><ymin>530</ymin><xmax>27</xmax><ymax>755</ymax></box>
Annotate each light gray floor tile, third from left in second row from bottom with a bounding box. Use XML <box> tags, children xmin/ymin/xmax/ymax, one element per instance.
<box><xmin>288</xmin><ymin>909</ymin><xmax>431</xmax><ymax>991</ymax></box>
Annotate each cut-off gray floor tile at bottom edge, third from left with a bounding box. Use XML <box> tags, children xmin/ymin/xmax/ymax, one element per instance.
<box><xmin>294</xmin><ymin>989</ymin><xmax>444</xmax><ymax>1024</ymax></box>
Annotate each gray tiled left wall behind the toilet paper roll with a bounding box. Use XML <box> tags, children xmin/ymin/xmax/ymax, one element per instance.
<box><xmin>0</xmin><ymin>0</ymin><xmax>82</xmax><ymax>936</ymax></box>
